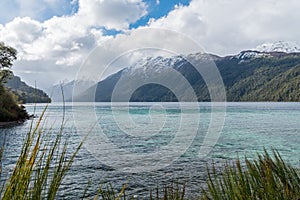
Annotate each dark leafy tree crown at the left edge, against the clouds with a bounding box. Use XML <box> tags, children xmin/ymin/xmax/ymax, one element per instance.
<box><xmin>0</xmin><ymin>42</ymin><xmax>17</xmax><ymax>84</ymax></box>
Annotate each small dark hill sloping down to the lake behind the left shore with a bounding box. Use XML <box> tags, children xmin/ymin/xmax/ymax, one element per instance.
<box><xmin>5</xmin><ymin>76</ymin><xmax>51</xmax><ymax>103</ymax></box>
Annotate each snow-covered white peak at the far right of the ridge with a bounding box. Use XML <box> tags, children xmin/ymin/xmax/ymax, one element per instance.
<box><xmin>253</xmin><ymin>41</ymin><xmax>300</xmax><ymax>53</ymax></box>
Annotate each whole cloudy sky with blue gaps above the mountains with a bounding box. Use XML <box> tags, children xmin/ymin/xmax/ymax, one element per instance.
<box><xmin>0</xmin><ymin>0</ymin><xmax>300</xmax><ymax>89</ymax></box>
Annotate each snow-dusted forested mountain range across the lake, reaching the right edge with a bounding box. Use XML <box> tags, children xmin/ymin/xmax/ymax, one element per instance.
<box><xmin>56</xmin><ymin>41</ymin><xmax>300</xmax><ymax>102</ymax></box>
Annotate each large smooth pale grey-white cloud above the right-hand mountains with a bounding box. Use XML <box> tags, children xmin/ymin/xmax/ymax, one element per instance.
<box><xmin>149</xmin><ymin>0</ymin><xmax>300</xmax><ymax>55</ymax></box>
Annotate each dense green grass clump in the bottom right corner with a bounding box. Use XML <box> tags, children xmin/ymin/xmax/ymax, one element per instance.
<box><xmin>202</xmin><ymin>150</ymin><xmax>300</xmax><ymax>200</ymax></box>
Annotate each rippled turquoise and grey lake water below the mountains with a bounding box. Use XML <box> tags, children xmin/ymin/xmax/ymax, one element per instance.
<box><xmin>0</xmin><ymin>103</ymin><xmax>300</xmax><ymax>199</ymax></box>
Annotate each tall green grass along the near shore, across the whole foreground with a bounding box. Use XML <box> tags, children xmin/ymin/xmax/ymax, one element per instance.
<box><xmin>0</xmin><ymin>106</ymin><xmax>300</xmax><ymax>200</ymax></box>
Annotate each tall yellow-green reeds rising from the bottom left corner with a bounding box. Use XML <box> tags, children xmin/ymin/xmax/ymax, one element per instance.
<box><xmin>0</xmin><ymin>107</ymin><xmax>83</xmax><ymax>200</ymax></box>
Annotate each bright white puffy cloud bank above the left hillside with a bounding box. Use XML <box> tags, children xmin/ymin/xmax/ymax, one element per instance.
<box><xmin>0</xmin><ymin>0</ymin><xmax>147</xmax><ymax>87</ymax></box>
